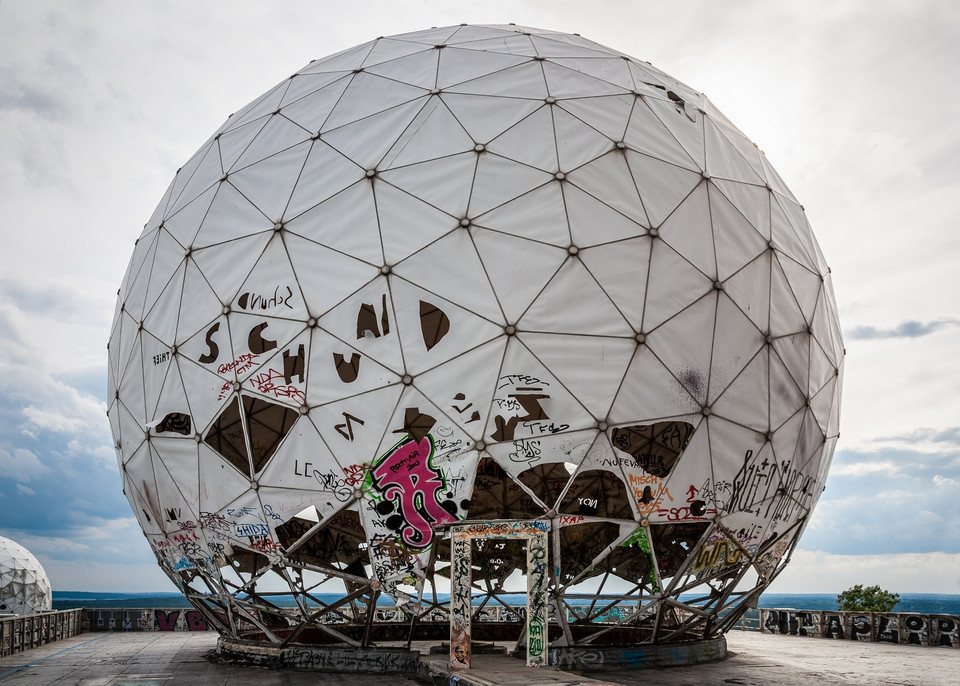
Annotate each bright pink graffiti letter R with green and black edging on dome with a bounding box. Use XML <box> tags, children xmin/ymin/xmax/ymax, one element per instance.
<box><xmin>370</xmin><ymin>434</ymin><xmax>457</xmax><ymax>548</ymax></box>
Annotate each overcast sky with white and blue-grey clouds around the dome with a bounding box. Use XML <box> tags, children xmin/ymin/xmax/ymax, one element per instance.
<box><xmin>0</xmin><ymin>0</ymin><xmax>960</xmax><ymax>593</ymax></box>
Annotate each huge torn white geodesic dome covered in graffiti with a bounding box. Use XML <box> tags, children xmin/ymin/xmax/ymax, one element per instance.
<box><xmin>109</xmin><ymin>25</ymin><xmax>844</xmax><ymax>656</ymax></box>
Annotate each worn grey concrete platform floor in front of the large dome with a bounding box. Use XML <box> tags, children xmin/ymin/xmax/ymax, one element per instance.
<box><xmin>0</xmin><ymin>631</ymin><xmax>960</xmax><ymax>686</ymax></box>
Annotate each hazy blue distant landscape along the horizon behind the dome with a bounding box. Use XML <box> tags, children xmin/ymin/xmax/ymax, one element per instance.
<box><xmin>53</xmin><ymin>591</ymin><xmax>960</xmax><ymax>615</ymax></box>
